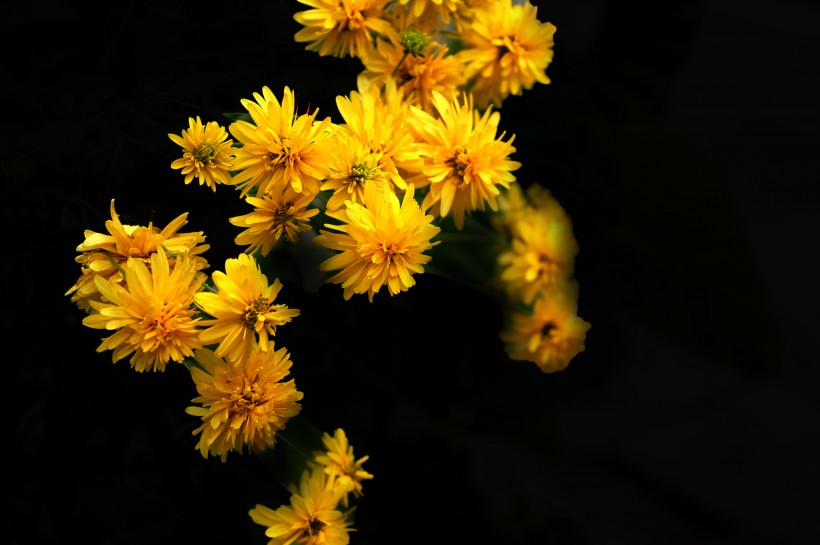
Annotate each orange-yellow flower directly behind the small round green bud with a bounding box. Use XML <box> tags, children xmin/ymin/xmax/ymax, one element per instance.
<box><xmin>359</xmin><ymin>32</ymin><xmax>467</xmax><ymax>111</ymax></box>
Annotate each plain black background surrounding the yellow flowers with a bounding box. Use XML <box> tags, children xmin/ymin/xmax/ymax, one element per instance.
<box><xmin>0</xmin><ymin>0</ymin><xmax>820</xmax><ymax>545</ymax></box>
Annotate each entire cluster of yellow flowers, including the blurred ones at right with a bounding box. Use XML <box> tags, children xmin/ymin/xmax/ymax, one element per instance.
<box><xmin>66</xmin><ymin>0</ymin><xmax>590</xmax><ymax>545</ymax></box>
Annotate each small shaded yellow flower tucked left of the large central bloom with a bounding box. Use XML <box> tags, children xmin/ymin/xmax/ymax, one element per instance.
<box><xmin>228</xmin><ymin>185</ymin><xmax>319</xmax><ymax>256</ymax></box>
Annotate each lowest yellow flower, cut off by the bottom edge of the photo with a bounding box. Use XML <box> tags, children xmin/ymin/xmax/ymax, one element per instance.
<box><xmin>248</xmin><ymin>469</ymin><xmax>353</xmax><ymax>545</ymax></box>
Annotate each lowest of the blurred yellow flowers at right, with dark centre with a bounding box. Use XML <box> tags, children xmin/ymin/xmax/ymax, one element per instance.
<box><xmin>500</xmin><ymin>281</ymin><xmax>590</xmax><ymax>373</ymax></box>
